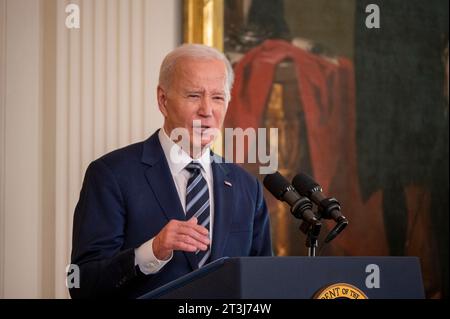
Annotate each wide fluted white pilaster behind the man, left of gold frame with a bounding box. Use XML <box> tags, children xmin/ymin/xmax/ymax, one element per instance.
<box><xmin>55</xmin><ymin>0</ymin><xmax>181</xmax><ymax>298</ymax></box>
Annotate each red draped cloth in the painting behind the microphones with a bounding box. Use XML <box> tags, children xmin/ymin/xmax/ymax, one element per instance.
<box><xmin>224</xmin><ymin>40</ymin><xmax>436</xmax><ymax>270</ymax></box>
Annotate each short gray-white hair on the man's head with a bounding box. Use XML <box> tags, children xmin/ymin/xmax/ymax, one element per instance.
<box><xmin>159</xmin><ymin>44</ymin><xmax>234</xmax><ymax>102</ymax></box>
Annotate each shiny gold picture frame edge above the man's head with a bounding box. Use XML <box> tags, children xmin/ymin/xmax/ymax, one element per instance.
<box><xmin>183</xmin><ymin>0</ymin><xmax>224</xmax><ymax>52</ymax></box>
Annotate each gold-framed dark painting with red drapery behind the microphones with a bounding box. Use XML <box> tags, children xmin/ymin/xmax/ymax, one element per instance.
<box><xmin>184</xmin><ymin>0</ymin><xmax>449</xmax><ymax>298</ymax></box>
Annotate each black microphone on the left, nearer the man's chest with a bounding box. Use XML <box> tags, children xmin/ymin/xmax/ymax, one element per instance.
<box><xmin>263</xmin><ymin>172</ymin><xmax>322</xmax><ymax>231</ymax></box>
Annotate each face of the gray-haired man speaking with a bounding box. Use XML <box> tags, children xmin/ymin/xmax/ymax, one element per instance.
<box><xmin>158</xmin><ymin>58</ymin><xmax>228</xmax><ymax>154</ymax></box>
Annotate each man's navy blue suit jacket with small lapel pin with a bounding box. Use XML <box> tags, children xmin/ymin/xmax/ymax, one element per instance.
<box><xmin>70</xmin><ymin>132</ymin><xmax>272</xmax><ymax>298</ymax></box>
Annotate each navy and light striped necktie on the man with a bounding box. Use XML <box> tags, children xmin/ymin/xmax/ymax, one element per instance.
<box><xmin>186</xmin><ymin>162</ymin><xmax>211</xmax><ymax>268</ymax></box>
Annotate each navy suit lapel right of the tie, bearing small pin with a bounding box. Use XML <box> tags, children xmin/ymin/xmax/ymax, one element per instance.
<box><xmin>211</xmin><ymin>156</ymin><xmax>234</xmax><ymax>260</ymax></box>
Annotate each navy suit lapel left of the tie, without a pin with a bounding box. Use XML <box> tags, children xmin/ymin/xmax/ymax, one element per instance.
<box><xmin>142</xmin><ymin>131</ymin><xmax>198</xmax><ymax>269</ymax></box>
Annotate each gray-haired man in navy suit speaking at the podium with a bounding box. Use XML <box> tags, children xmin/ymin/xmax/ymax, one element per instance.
<box><xmin>70</xmin><ymin>45</ymin><xmax>272</xmax><ymax>298</ymax></box>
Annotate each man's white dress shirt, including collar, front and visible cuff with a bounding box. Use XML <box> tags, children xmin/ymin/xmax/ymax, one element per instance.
<box><xmin>135</xmin><ymin>128</ymin><xmax>214</xmax><ymax>275</ymax></box>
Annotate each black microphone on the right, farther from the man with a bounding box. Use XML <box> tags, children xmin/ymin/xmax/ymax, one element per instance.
<box><xmin>292</xmin><ymin>173</ymin><xmax>348</xmax><ymax>243</ymax></box>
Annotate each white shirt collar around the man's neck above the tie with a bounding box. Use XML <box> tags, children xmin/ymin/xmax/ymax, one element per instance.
<box><xmin>158</xmin><ymin>127</ymin><xmax>211</xmax><ymax>176</ymax></box>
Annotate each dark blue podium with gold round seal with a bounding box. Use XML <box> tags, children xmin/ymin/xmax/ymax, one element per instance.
<box><xmin>142</xmin><ymin>257</ymin><xmax>425</xmax><ymax>299</ymax></box>
